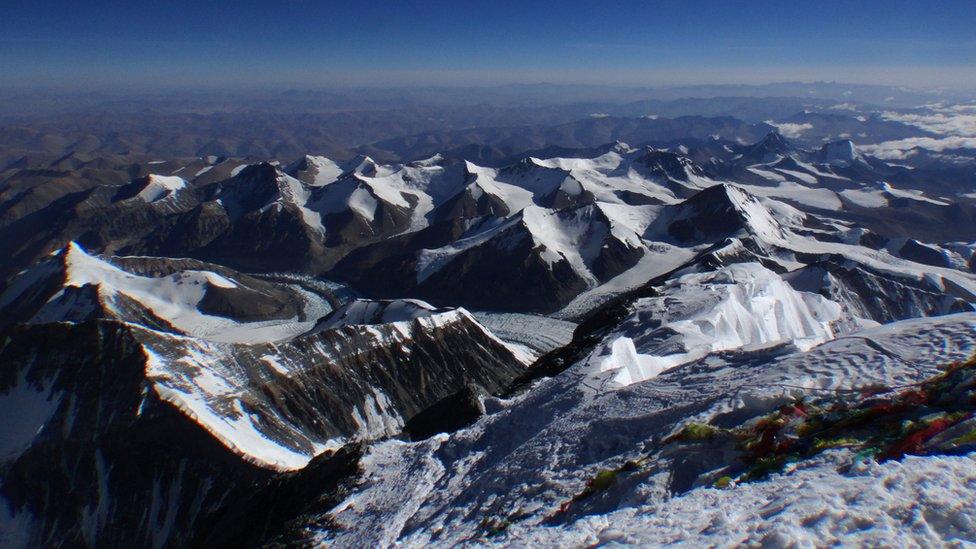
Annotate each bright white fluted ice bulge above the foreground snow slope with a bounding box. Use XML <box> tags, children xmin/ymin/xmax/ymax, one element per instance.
<box><xmin>596</xmin><ymin>263</ymin><xmax>842</xmax><ymax>386</ymax></box>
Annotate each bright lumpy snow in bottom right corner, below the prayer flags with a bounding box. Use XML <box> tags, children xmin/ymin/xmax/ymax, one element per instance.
<box><xmin>516</xmin><ymin>451</ymin><xmax>976</xmax><ymax>547</ymax></box>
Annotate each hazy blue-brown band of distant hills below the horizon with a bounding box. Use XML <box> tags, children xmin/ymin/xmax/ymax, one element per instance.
<box><xmin>0</xmin><ymin>83</ymin><xmax>968</xmax><ymax>165</ymax></box>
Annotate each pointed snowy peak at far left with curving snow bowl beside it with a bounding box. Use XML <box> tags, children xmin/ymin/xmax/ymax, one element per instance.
<box><xmin>0</xmin><ymin>242</ymin><xmax>328</xmax><ymax>343</ymax></box>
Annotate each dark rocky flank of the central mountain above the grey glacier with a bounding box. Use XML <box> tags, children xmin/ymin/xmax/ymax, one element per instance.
<box><xmin>330</xmin><ymin>201</ymin><xmax>644</xmax><ymax>313</ymax></box>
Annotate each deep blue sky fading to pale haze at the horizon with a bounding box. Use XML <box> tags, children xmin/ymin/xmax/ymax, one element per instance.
<box><xmin>0</xmin><ymin>0</ymin><xmax>976</xmax><ymax>88</ymax></box>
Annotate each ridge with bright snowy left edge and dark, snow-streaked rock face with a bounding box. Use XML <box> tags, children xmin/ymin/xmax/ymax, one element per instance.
<box><xmin>137</xmin><ymin>300</ymin><xmax>530</xmax><ymax>471</ymax></box>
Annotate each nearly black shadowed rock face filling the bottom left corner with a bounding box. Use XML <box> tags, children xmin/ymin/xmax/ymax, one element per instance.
<box><xmin>0</xmin><ymin>321</ymin><xmax>271</xmax><ymax>546</ymax></box>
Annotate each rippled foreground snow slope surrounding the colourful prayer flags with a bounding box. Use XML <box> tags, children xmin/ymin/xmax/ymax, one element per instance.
<box><xmin>318</xmin><ymin>313</ymin><xmax>976</xmax><ymax>547</ymax></box>
